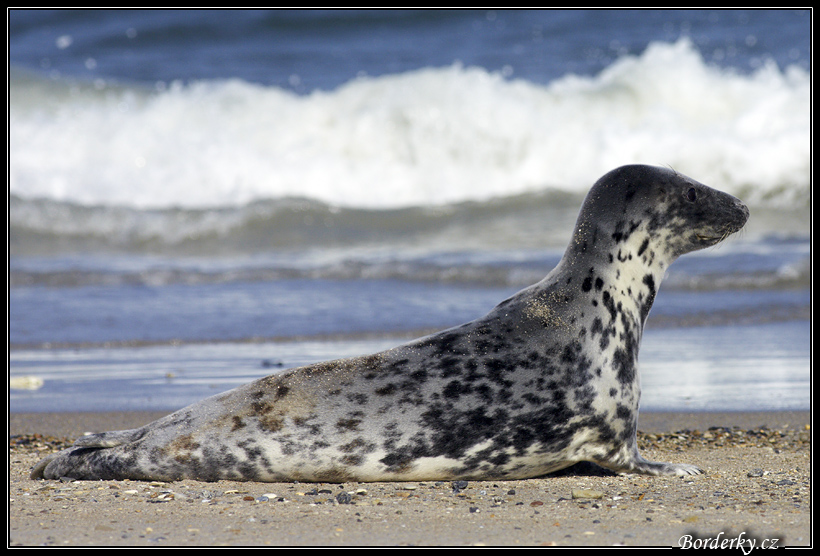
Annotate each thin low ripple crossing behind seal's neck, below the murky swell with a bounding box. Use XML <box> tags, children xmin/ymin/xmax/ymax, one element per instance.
<box><xmin>9</xmin><ymin>254</ymin><xmax>811</xmax><ymax>292</ymax></box>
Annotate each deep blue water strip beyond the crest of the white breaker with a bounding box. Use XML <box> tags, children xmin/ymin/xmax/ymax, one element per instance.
<box><xmin>9</xmin><ymin>10</ymin><xmax>811</xmax><ymax>93</ymax></box>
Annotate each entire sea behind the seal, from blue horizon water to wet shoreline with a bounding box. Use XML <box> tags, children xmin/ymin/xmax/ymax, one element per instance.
<box><xmin>8</xmin><ymin>10</ymin><xmax>812</xmax><ymax>411</ymax></box>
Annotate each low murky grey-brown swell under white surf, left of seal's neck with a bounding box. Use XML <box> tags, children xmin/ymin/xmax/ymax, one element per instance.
<box><xmin>9</xmin><ymin>191</ymin><xmax>581</xmax><ymax>256</ymax></box>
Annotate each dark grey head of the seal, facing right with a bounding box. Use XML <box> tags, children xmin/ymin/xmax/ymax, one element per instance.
<box><xmin>573</xmin><ymin>164</ymin><xmax>749</xmax><ymax>266</ymax></box>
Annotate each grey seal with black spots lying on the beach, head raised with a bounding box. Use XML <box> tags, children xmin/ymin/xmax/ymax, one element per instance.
<box><xmin>31</xmin><ymin>165</ymin><xmax>749</xmax><ymax>482</ymax></box>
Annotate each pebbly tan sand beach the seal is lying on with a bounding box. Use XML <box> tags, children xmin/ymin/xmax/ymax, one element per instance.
<box><xmin>9</xmin><ymin>412</ymin><xmax>811</xmax><ymax>547</ymax></box>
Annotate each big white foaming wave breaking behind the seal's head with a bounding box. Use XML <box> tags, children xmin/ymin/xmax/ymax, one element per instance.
<box><xmin>9</xmin><ymin>39</ymin><xmax>811</xmax><ymax>211</ymax></box>
